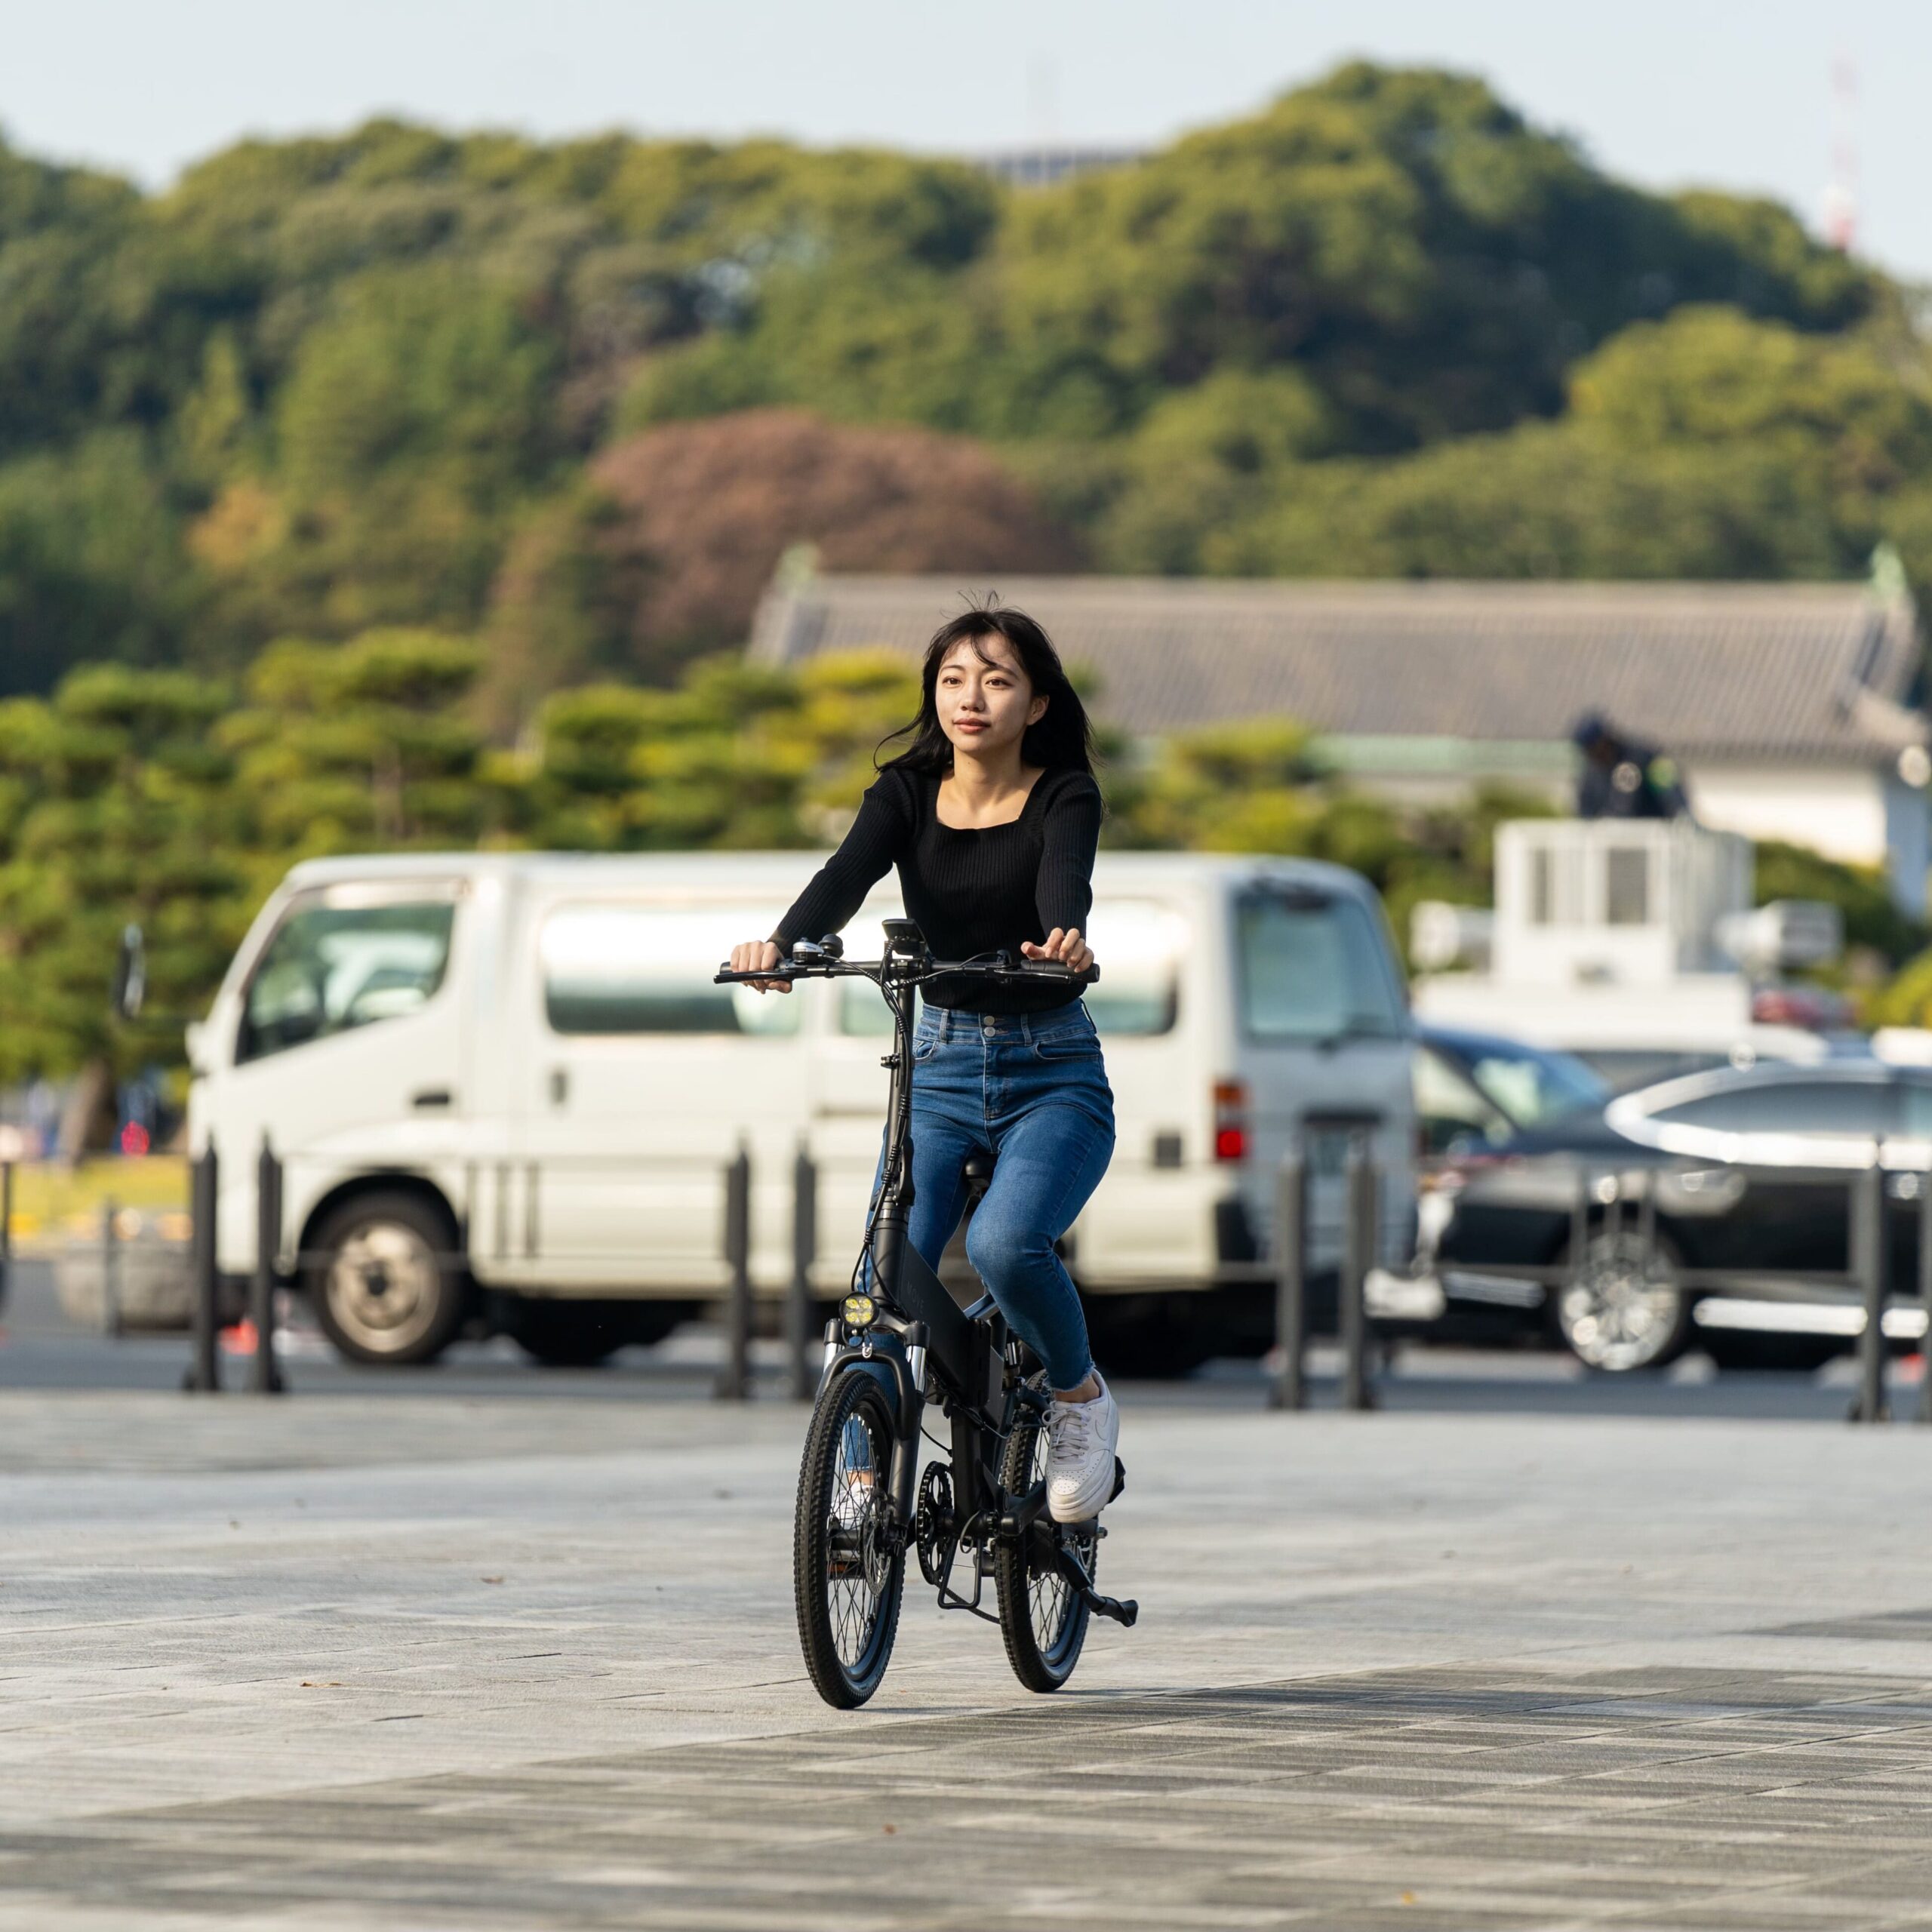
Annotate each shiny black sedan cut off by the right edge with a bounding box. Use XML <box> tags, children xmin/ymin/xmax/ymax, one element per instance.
<box><xmin>1424</xmin><ymin>1060</ymin><xmax>1932</xmax><ymax>1370</ymax></box>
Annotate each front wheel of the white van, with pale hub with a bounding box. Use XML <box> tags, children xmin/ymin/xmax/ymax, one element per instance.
<box><xmin>305</xmin><ymin>1192</ymin><xmax>469</xmax><ymax>1367</ymax></box>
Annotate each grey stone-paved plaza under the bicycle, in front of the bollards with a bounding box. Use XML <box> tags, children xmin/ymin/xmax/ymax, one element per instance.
<box><xmin>0</xmin><ymin>1393</ymin><xmax>1932</xmax><ymax>1932</ymax></box>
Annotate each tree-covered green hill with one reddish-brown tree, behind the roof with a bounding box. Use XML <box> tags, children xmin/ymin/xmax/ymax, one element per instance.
<box><xmin>0</xmin><ymin>66</ymin><xmax>1932</xmax><ymax>731</ymax></box>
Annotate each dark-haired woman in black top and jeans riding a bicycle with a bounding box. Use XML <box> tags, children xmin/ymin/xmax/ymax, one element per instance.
<box><xmin>731</xmin><ymin>607</ymin><xmax>1121</xmax><ymax>1522</ymax></box>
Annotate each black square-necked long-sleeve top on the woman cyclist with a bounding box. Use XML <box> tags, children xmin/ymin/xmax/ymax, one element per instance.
<box><xmin>771</xmin><ymin>765</ymin><xmax>1101</xmax><ymax>1012</ymax></box>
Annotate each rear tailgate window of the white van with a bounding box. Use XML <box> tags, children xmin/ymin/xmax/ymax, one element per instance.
<box><xmin>1235</xmin><ymin>891</ymin><xmax>1408</xmax><ymax>1041</ymax></box>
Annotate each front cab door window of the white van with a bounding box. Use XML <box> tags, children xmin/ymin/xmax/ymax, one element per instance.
<box><xmin>235</xmin><ymin>898</ymin><xmax>456</xmax><ymax>1065</ymax></box>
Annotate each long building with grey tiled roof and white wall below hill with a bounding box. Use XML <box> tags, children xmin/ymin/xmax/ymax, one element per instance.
<box><xmin>752</xmin><ymin>576</ymin><xmax>1932</xmax><ymax>904</ymax></box>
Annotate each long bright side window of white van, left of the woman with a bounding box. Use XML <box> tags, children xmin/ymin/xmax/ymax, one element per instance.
<box><xmin>537</xmin><ymin>904</ymin><xmax>808</xmax><ymax>1035</ymax></box>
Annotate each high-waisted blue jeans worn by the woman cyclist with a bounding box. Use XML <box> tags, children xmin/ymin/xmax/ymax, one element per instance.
<box><xmin>881</xmin><ymin>1003</ymin><xmax>1113</xmax><ymax>1389</ymax></box>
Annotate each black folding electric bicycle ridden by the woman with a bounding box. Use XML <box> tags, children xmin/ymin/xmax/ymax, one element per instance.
<box><xmin>717</xmin><ymin>920</ymin><xmax>1140</xmax><ymax>1710</ymax></box>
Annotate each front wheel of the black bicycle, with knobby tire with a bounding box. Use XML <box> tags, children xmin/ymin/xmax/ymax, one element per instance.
<box><xmin>792</xmin><ymin>1367</ymin><xmax>906</xmax><ymax>1710</ymax></box>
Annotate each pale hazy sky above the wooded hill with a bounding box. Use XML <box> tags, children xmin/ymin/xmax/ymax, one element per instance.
<box><xmin>11</xmin><ymin>0</ymin><xmax>1932</xmax><ymax>282</ymax></box>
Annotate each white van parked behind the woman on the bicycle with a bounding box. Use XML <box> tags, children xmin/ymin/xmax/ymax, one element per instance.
<box><xmin>189</xmin><ymin>852</ymin><xmax>1414</xmax><ymax>1372</ymax></box>
